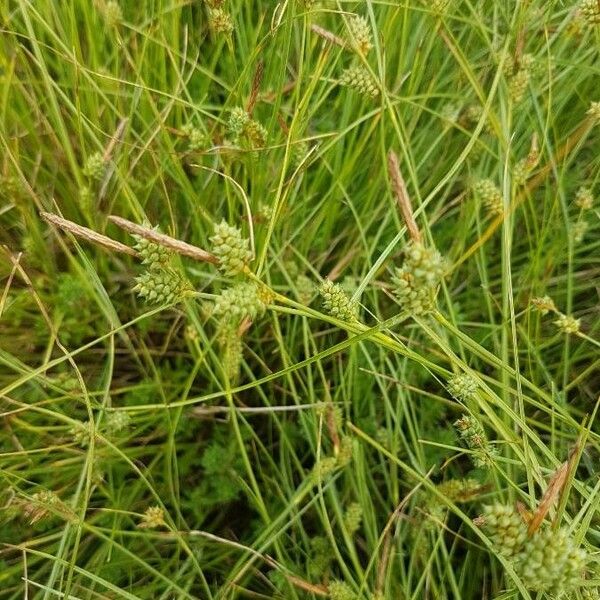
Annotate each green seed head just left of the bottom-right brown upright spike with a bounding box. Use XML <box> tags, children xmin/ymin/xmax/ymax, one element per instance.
<box><xmin>479</xmin><ymin>504</ymin><xmax>527</xmax><ymax>558</ymax></box>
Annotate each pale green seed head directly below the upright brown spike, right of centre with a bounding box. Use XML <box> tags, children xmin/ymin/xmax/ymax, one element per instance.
<box><xmin>392</xmin><ymin>242</ymin><xmax>446</xmax><ymax>315</ymax></box>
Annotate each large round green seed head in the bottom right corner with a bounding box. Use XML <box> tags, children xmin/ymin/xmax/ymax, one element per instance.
<box><xmin>514</xmin><ymin>529</ymin><xmax>587</xmax><ymax>594</ymax></box>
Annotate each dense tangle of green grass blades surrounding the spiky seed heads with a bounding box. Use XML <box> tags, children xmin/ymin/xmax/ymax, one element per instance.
<box><xmin>0</xmin><ymin>0</ymin><xmax>600</xmax><ymax>600</ymax></box>
